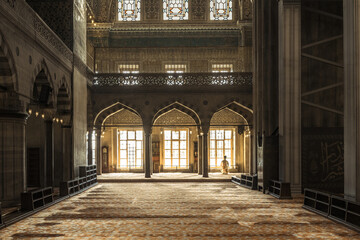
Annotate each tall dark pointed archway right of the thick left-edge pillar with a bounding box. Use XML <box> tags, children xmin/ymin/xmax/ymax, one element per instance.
<box><xmin>26</xmin><ymin>61</ymin><xmax>55</xmax><ymax>188</ymax></box>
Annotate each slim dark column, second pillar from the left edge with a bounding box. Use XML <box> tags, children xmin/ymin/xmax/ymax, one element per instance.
<box><xmin>45</xmin><ymin>120</ymin><xmax>54</xmax><ymax>187</ymax></box>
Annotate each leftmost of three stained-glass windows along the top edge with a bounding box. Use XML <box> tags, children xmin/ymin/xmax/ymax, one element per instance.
<box><xmin>118</xmin><ymin>0</ymin><xmax>141</xmax><ymax>21</ymax></box>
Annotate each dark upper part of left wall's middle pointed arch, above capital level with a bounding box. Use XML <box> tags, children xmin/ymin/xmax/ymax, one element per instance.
<box><xmin>30</xmin><ymin>59</ymin><xmax>56</xmax><ymax>107</ymax></box>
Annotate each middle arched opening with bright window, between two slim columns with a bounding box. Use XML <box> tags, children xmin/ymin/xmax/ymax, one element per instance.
<box><xmin>152</xmin><ymin>108</ymin><xmax>198</xmax><ymax>173</ymax></box>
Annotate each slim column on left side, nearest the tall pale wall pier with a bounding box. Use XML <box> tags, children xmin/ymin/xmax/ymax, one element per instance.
<box><xmin>61</xmin><ymin>125</ymin><xmax>75</xmax><ymax>181</ymax></box>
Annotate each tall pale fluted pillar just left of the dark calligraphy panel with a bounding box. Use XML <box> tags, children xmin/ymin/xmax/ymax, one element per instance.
<box><xmin>279</xmin><ymin>0</ymin><xmax>301</xmax><ymax>193</ymax></box>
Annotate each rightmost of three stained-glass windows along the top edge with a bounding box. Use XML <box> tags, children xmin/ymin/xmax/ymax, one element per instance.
<box><xmin>210</xmin><ymin>0</ymin><xmax>232</xmax><ymax>20</ymax></box>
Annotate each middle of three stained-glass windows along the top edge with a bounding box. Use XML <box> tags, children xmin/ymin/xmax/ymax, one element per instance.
<box><xmin>163</xmin><ymin>0</ymin><xmax>189</xmax><ymax>20</ymax></box>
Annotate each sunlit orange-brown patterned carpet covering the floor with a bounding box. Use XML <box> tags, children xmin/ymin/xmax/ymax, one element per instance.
<box><xmin>0</xmin><ymin>183</ymin><xmax>360</xmax><ymax>239</ymax></box>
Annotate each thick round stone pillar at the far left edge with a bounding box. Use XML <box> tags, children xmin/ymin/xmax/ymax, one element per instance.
<box><xmin>0</xmin><ymin>112</ymin><xmax>28</xmax><ymax>207</ymax></box>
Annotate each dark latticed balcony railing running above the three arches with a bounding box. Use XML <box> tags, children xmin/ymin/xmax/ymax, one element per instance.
<box><xmin>93</xmin><ymin>72</ymin><xmax>252</xmax><ymax>87</ymax></box>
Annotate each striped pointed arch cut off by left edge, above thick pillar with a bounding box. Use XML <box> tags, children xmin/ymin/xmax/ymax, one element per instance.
<box><xmin>0</xmin><ymin>31</ymin><xmax>19</xmax><ymax>91</ymax></box>
